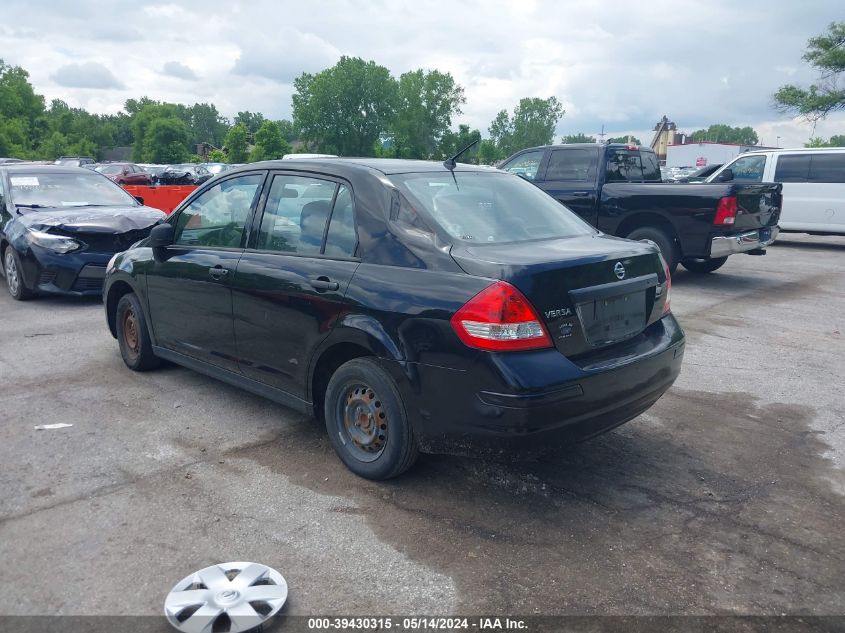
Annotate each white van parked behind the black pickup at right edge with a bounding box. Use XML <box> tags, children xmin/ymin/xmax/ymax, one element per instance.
<box><xmin>707</xmin><ymin>147</ymin><xmax>845</xmax><ymax>235</ymax></box>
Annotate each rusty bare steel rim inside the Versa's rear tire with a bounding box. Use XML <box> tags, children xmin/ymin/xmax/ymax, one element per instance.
<box><xmin>338</xmin><ymin>383</ymin><xmax>387</xmax><ymax>461</ymax></box>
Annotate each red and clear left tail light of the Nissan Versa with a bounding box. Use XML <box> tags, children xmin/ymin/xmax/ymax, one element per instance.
<box><xmin>452</xmin><ymin>281</ymin><xmax>552</xmax><ymax>352</ymax></box>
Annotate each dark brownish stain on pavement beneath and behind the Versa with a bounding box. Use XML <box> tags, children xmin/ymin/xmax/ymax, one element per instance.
<box><xmin>232</xmin><ymin>388</ymin><xmax>845</xmax><ymax>614</ymax></box>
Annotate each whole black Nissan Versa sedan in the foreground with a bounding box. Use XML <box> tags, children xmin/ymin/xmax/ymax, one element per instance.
<box><xmin>103</xmin><ymin>159</ymin><xmax>684</xmax><ymax>479</ymax></box>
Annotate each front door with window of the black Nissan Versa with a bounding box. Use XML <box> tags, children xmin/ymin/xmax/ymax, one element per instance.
<box><xmin>147</xmin><ymin>171</ymin><xmax>266</xmax><ymax>371</ymax></box>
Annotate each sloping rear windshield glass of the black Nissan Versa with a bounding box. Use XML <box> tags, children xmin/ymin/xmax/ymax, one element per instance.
<box><xmin>390</xmin><ymin>171</ymin><xmax>595</xmax><ymax>244</ymax></box>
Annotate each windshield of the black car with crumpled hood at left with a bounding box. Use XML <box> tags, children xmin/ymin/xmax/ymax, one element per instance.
<box><xmin>9</xmin><ymin>170</ymin><xmax>138</xmax><ymax>207</ymax></box>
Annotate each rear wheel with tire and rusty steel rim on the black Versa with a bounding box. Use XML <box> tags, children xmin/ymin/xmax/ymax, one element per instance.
<box><xmin>324</xmin><ymin>358</ymin><xmax>419</xmax><ymax>480</ymax></box>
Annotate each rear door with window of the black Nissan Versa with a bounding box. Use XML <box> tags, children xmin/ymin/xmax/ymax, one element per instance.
<box><xmin>232</xmin><ymin>172</ymin><xmax>358</xmax><ymax>399</ymax></box>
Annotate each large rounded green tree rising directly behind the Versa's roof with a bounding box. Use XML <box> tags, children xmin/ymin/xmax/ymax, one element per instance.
<box><xmin>293</xmin><ymin>57</ymin><xmax>397</xmax><ymax>156</ymax></box>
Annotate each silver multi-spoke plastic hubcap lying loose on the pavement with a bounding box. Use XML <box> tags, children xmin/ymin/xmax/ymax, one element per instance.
<box><xmin>164</xmin><ymin>563</ymin><xmax>288</xmax><ymax>633</ymax></box>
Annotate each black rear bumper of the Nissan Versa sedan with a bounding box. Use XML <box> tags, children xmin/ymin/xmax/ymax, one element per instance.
<box><xmin>380</xmin><ymin>315</ymin><xmax>684</xmax><ymax>454</ymax></box>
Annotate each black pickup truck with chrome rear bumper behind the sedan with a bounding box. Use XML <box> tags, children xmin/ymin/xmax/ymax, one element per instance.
<box><xmin>502</xmin><ymin>143</ymin><xmax>781</xmax><ymax>273</ymax></box>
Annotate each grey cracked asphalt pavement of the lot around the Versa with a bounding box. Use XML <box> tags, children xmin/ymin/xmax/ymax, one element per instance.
<box><xmin>0</xmin><ymin>235</ymin><xmax>845</xmax><ymax>615</ymax></box>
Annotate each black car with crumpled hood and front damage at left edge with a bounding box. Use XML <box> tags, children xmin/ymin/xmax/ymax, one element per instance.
<box><xmin>0</xmin><ymin>164</ymin><xmax>164</xmax><ymax>299</ymax></box>
